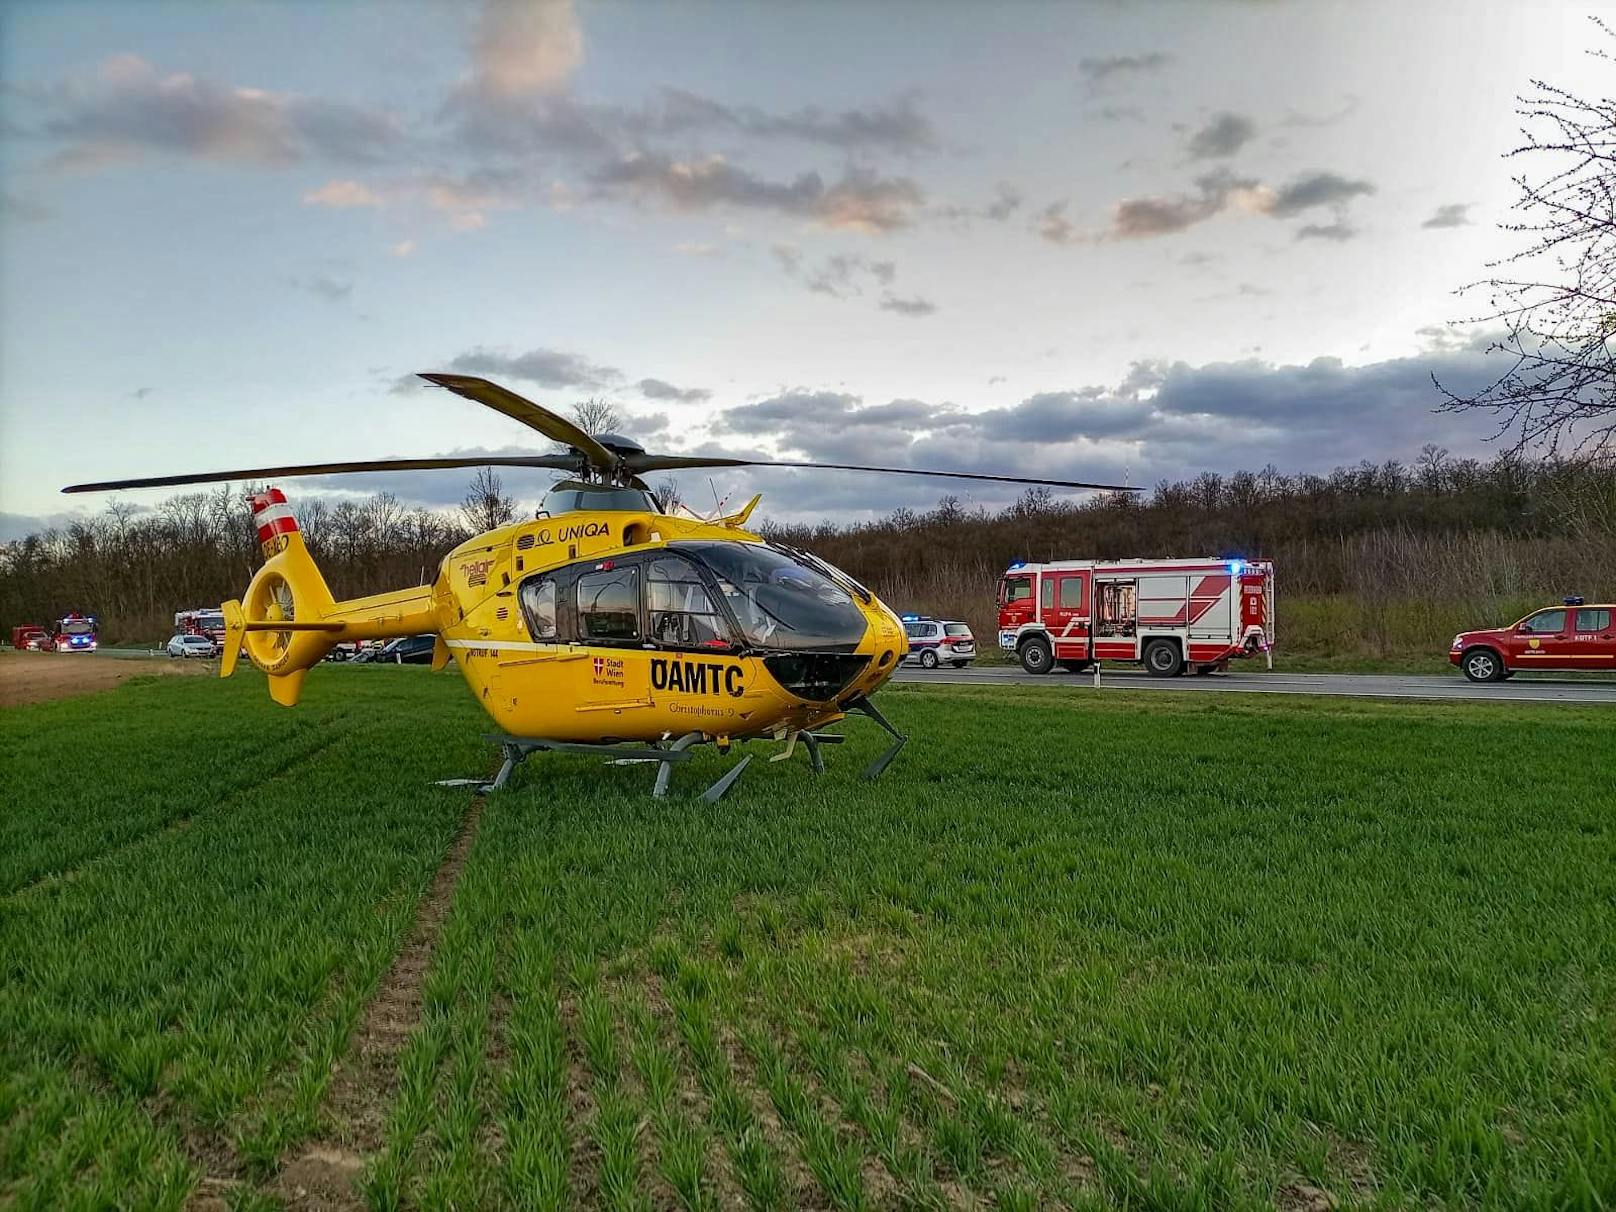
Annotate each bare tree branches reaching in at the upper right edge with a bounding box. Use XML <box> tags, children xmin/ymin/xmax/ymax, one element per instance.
<box><xmin>1437</xmin><ymin>18</ymin><xmax>1616</xmax><ymax>454</ymax></box>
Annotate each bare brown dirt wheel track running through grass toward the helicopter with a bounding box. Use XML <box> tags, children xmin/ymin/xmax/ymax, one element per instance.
<box><xmin>270</xmin><ymin>795</ymin><xmax>485</xmax><ymax>1209</ymax></box>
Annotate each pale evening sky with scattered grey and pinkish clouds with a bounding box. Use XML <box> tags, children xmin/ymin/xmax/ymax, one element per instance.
<box><xmin>0</xmin><ymin>0</ymin><xmax>1610</xmax><ymax>533</ymax></box>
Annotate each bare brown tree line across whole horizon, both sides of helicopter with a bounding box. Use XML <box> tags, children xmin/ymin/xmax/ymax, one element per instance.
<box><xmin>0</xmin><ymin>448</ymin><xmax>1616</xmax><ymax>642</ymax></box>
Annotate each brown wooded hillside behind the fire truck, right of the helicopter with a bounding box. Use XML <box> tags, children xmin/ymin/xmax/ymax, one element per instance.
<box><xmin>771</xmin><ymin>446</ymin><xmax>1616</xmax><ymax>654</ymax></box>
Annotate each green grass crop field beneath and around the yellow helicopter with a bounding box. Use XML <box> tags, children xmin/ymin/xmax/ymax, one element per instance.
<box><xmin>0</xmin><ymin>667</ymin><xmax>1616</xmax><ymax>1209</ymax></box>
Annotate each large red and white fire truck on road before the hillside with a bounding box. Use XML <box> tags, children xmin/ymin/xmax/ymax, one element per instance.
<box><xmin>999</xmin><ymin>559</ymin><xmax>1273</xmax><ymax>677</ymax></box>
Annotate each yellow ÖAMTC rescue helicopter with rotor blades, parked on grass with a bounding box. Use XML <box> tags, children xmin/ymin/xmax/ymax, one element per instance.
<box><xmin>63</xmin><ymin>373</ymin><xmax>1128</xmax><ymax>800</ymax></box>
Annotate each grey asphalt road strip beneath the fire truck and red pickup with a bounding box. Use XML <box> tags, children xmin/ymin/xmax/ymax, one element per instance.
<box><xmin>894</xmin><ymin>666</ymin><xmax>1616</xmax><ymax>705</ymax></box>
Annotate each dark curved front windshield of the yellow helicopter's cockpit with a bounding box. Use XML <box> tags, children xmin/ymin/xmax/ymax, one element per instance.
<box><xmin>671</xmin><ymin>541</ymin><xmax>865</xmax><ymax>653</ymax></box>
